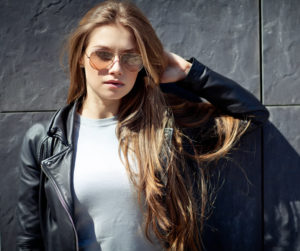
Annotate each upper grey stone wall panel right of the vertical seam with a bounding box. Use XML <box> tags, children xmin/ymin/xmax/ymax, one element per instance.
<box><xmin>262</xmin><ymin>0</ymin><xmax>300</xmax><ymax>105</ymax></box>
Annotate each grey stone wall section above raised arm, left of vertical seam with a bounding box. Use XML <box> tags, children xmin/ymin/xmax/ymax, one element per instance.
<box><xmin>135</xmin><ymin>0</ymin><xmax>260</xmax><ymax>97</ymax></box>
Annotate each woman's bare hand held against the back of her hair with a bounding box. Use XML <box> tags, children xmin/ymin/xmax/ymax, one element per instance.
<box><xmin>160</xmin><ymin>51</ymin><xmax>192</xmax><ymax>83</ymax></box>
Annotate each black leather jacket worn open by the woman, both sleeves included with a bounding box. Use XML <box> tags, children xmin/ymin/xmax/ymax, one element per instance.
<box><xmin>17</xmin><ymin>59</ymin><xmax>268</xmax><ymax>251</ymax></box>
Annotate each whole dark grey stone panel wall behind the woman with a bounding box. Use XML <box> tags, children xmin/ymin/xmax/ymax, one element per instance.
<box><xmin>0</xmin><ymin>0</ymin><xmax>300</xmax><ymax>251</ymax></box>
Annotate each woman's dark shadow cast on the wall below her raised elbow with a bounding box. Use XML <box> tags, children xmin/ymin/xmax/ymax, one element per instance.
<box><xmin>203</xmin><ymin>122</ymin><xmax>300</xmax><ymax>251</ymax></box>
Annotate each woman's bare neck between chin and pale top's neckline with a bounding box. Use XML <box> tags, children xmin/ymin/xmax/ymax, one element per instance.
<box><xmin>78</xmin><ymin>97</ymin><xmax>120</xmax><ymax>119</ymax></box>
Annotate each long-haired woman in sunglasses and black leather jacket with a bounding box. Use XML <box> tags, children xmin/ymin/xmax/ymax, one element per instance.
<box><xmin>17</xmin><ymin>1</ymin><xmax>268</xmax><ymax>250</ymax></box>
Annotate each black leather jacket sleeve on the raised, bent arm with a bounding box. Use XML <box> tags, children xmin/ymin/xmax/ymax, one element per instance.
<box><xmin>161</xmin><ymin>58</ymin><xmax>269</xmax><ymax>126</ymax></box>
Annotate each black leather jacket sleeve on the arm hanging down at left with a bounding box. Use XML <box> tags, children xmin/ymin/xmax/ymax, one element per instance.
<box><xmin>16</xmin><ymin>124</ymin><xmax>45</xmax><ymax>251</ymax></box>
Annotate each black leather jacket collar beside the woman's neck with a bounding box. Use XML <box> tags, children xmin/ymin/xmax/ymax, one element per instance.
<box><xmin>47</xmin><ymin>100</ymin><xmax>78</xmax><ymax>145</ymax></box>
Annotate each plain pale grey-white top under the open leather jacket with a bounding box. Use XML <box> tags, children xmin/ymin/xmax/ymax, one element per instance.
<box><xmin>74</xmin><ymin>115</ymin><xmax>163</xmax><ymax>251</ymax></box>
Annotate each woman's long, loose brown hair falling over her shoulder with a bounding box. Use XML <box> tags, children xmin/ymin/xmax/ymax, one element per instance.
<box><xmin>68</xmin><ymin>1</ymin><xmax>251</xmax><ymax>250</ymax></box>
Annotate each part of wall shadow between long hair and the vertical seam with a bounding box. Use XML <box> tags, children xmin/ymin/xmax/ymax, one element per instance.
<box><xmin>203</xmin><ymin>129</ymin><xmax>262</xmax><ymax>251</ymax></box>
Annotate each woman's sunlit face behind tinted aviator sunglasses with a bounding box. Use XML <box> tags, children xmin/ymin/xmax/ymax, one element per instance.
<box><xmin>81</xmin><ymin>24</ymin><xmax>139</xmax><ymax>108</ymax></box>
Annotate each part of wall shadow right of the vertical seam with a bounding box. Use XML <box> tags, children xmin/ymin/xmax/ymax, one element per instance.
<box><xmin>264</xmin><ymin>123</ymin><xmax>300</xmax><ymax>251</ymax></box>
